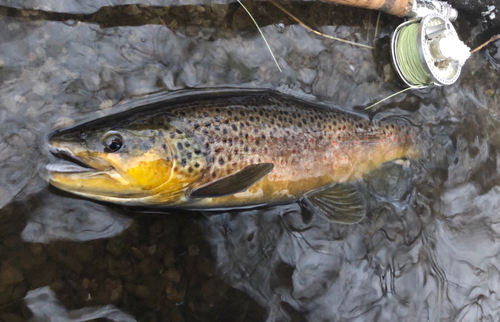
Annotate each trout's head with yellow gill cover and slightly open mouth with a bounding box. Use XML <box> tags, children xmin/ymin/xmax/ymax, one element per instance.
<box><xmin>47</xmin><ymin>117</ymin><xmax>206</xmax><ymax>205</ymax></box>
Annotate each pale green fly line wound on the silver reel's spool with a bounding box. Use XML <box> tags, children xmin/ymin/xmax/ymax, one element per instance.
<box><xmin>396</xmin><ymin>23</ymin><xmax>433</xmax><ymax>86</ymax></box>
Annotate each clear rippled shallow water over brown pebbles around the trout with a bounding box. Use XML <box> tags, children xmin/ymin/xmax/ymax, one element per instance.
<box><xmin>0</xmin><ymin>0</ymin><xmax>500</xmax><ymax>322</ymax></box>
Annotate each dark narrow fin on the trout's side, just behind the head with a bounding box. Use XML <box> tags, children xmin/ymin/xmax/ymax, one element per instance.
<box><xmin>189</xmin><ymin>163</ymin><xmax>274</xmax><ymax>198</ymax></box>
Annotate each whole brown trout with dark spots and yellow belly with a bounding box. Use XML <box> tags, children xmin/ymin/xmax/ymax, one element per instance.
<box><xmin>47</xmin><ymin>91</ymin><xmax>416</xmax><ymax>223</ymax></box>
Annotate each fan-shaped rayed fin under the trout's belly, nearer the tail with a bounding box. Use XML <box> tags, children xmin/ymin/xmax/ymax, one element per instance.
<box><xmin>303</xmin><ymin>184</ymin><xmax>366</xmax><ymax>224</ymax></box>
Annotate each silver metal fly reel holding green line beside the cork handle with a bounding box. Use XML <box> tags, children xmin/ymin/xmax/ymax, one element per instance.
<box><xmin>391</xmin><ymin>0</ymin><xmax>470</xmax><ymax>88</ymax></box>
